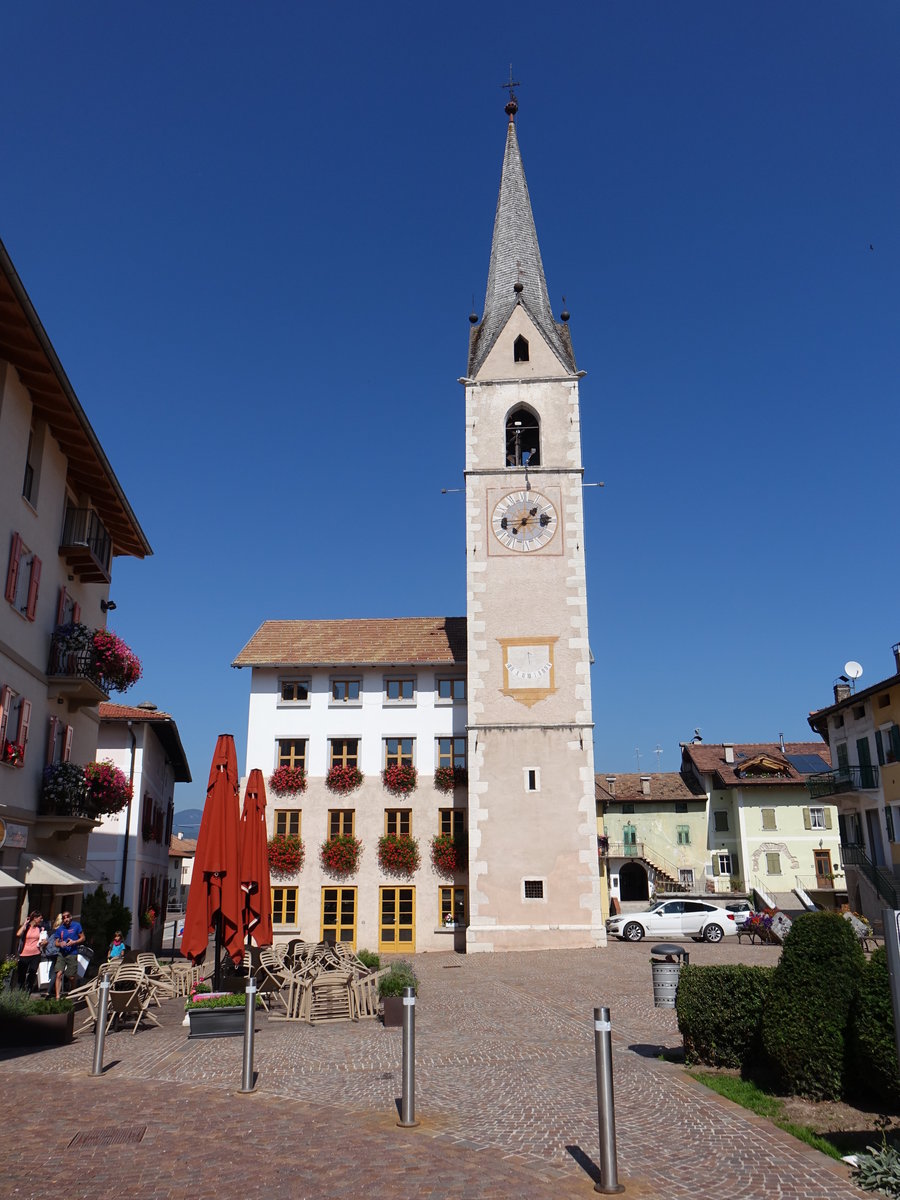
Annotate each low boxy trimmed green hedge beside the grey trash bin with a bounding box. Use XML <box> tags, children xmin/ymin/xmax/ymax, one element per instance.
<box><xmin>676</xmin><ymin>966</ymin><xmax>775</xmax><ymax>1067</ymax></box>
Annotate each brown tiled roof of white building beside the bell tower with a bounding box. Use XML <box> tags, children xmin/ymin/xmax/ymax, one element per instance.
<box><xmin>232</xmin><ymin>617</ymin><xmax>466</xmax><ymax>667</ymax></box>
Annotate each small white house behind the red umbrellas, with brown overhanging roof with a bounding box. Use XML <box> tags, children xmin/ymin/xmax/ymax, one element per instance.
<box><xmin>86</xmin><ymin>703</ymin><xmax>191</xmax><ymax>949</ymax></box>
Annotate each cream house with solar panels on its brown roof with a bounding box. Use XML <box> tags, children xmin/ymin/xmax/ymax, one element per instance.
<box><xmin>682</xmin><ymin>742</ymin><xmax>846</xmax><ymax>911</ymax></box>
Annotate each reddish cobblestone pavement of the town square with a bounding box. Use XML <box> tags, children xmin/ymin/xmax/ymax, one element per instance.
<box><xmin>0</xmin><ymin>940</ymin><xmax>862</xmax><ymax>1200</ymax></box>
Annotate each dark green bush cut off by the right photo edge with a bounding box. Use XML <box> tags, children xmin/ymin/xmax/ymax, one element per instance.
<box><xmin>848</xmin><ymin>946</ymin><xmax>900</xmax><ymax>1109</ymax></box>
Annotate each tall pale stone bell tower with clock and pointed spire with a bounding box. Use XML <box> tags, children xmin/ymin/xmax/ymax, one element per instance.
<box><xmin>461</xmin><ymin>89</ymin><xmax>606</xmax><ymax>953</ymax></box>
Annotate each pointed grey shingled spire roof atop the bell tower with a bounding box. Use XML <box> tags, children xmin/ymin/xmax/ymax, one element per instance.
<box><xmin>468</xmin><ymin>112</ymin><xmax>575</xmax><ymax>377</ymax></box>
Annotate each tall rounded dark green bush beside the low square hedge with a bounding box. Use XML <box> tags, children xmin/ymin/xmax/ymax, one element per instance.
<box><xmin>762</xmin><ymin>912</ymin><xmax>865</xmax><ymax>1100</ymax></box>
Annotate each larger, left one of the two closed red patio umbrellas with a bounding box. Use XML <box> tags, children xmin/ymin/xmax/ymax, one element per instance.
<box><xmin>181</xmin><ymin>733</ymin><xmax>244</xmax><ymax>978</ymax></box>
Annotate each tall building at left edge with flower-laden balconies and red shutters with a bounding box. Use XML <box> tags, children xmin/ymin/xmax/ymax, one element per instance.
<box><xmin>0</xmin><ymin>231</ymin><xmax>151</xmax><ymax>953</ymax></box>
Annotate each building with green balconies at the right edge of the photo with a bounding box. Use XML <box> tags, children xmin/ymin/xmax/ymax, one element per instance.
<box><xmin>808</xmin><ymin>643</ymin><xmax>900</xmax><ymax>920</ymax></box>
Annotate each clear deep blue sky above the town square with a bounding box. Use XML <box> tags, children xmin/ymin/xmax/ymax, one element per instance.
<box><xmin>0</xmin><ymin>0</ymin><xmax>900</xmax><ymax>809</ymax></box>
